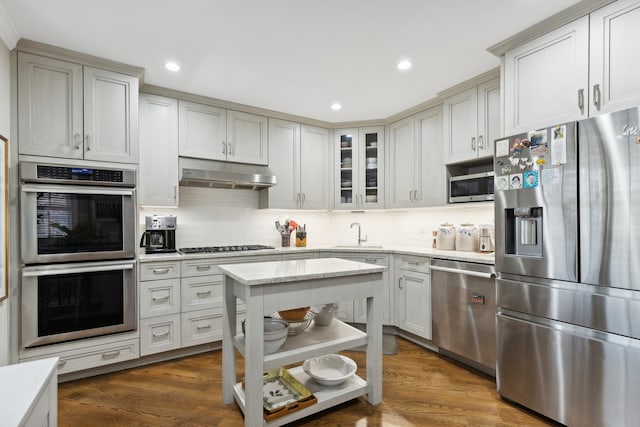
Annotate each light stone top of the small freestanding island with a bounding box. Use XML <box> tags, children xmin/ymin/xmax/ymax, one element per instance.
<box><xmin>219</xmin><ymin>258</ymin><xmax>387</xmax><ymax>286</ymax></box>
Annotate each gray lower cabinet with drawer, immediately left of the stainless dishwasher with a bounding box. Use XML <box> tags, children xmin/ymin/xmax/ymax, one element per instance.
<box><xmin>394</xmin><ymin>255</ymin><xmax>431</xmax><ymax>340</ymax></box>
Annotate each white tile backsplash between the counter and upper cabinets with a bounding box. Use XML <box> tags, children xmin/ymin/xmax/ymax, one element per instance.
<box><xmin>139</xmin><ymin>187</ymin><xmax>494</xmax><ymax>247</ymax></box>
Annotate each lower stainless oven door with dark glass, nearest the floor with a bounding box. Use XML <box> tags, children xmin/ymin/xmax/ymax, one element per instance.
<box><xmin>21</xmin><ymin>260</ymin><xmax>136</xmax><ymax>348</ymax></box>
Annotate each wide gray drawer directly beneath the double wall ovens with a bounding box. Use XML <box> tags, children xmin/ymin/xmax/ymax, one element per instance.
<box><xmin>53</xmin><ymin>339</ymin><xmax>140</xmax><ymax>375</ymax></box>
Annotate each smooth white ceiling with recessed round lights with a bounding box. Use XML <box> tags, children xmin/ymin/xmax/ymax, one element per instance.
<box><xmin>0</xmin><ymin>0</ymin><xmax>578</xmax><ymax>122</ymax></box>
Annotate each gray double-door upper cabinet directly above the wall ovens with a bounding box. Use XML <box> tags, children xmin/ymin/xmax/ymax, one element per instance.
<box><xmin>18</xmin><ymin>52</ymin><xmax>138</xmax><ymax>163</ymax></box>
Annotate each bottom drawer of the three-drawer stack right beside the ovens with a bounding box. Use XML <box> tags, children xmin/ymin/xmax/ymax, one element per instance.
<box><xmin>140</xmin><ymin>314</ymin><xmax>180</xmax><ymax>356</ymax></box>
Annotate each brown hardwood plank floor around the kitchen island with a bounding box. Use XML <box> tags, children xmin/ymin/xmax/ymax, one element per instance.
<box><xmin>58</xmin><ymin>339</ymin><xmax>550</xmax><ymax>427</ymax></box>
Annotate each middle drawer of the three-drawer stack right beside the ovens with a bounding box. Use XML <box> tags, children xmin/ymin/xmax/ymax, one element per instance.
<box><xmin>139</xmin><ymin>279</ymin><xmax>180</xmax><ymax>319</ymax></box>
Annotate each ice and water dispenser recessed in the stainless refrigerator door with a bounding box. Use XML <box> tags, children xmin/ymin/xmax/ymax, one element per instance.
<box><xmin>505</xmin><ymin>207</ymin><xmax>542</xmax><ymax>257</ymax></box>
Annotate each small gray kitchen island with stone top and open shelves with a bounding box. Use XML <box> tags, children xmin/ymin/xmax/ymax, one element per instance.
<box><xmin>219</xmin><ymin>258</ymin><xmax>386</xmax><ymax>426</ymax></box>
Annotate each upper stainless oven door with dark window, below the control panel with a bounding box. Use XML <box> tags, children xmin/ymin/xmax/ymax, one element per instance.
<box><xmin>20</xmin><ymin>184</ymin><xmax>136</xmax><ymax>264</ymax></box>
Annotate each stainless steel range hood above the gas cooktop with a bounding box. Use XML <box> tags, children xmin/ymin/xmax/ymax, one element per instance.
<box><xmin>178</xmin><ymin>157</ymin><xmax>276</xmax><ymax>190</ymax></box>
